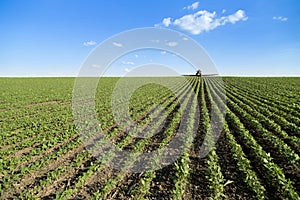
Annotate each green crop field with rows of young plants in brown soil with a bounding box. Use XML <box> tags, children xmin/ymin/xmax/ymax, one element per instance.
<box><xmin>0</xmin><ymin>76</ymin><xmax>300</xmax><ymax>199</ymax></box>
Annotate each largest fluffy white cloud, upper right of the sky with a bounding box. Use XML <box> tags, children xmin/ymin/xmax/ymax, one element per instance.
<box><xmin>161</xmin><ymin>10</ymin><xmax>248</xmax><ymax>35</ymax></box>
